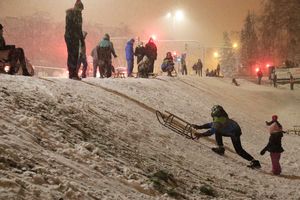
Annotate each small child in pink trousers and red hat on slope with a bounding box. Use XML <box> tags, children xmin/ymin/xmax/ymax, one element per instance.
<box><xmin>260</xmin><ymin>115</ymin><xmax>284</xmax><ymax>175</ymax></box>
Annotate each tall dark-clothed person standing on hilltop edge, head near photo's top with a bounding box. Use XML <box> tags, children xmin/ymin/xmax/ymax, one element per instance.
<box><xmin>65</xmin><ymin>0</ymin><xmax>85</xmax><ymax>80</ymax></box>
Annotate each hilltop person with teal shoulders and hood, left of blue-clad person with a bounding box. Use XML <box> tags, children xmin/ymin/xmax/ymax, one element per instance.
<box><xmin>97</xmin><ymin>33</ymin><xmax>117</xmax><ymax>78</ymax></box>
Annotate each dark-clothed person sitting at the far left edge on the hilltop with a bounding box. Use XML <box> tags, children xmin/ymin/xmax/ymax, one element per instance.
<box><xmin>0</xmin><ymin>24</ymin><xmax>32</xmax><ymax>76</ymax></box>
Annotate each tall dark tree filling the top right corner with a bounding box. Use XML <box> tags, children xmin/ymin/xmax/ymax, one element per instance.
<box><xmin>260</xmin><ymin>0</ymin><xmax>300</xmax><ymax>63</ymax></box>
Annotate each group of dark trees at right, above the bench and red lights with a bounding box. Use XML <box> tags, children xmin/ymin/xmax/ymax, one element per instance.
<box><xmin>240</xmin><ymin>0</ymin><xmax>300</xmax><ymax>72</ymax></box>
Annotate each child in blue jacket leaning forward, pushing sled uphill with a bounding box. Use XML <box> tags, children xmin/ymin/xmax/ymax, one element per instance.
<box><xmin>192</xmin><ymin>105</ymin><xmax>261</xmax><ymax>168</ymax></box>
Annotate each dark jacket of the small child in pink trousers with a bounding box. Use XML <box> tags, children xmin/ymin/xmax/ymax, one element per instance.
<box><xmin>261</xmin><ymin>131</ymin><xmax>284</xmax><ymax>155</ymax></box>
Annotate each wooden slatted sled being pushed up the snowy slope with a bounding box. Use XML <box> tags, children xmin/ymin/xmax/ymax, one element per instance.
<box><xmin>156</xmin><ymin>110</ymin><xmax>196</xmax><ymax>140</ymax></box>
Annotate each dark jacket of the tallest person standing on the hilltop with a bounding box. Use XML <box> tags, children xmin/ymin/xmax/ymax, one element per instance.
<box><xmin>65</xmin><ymin>9</ymin><xmax>84</xmax><ymax>44</ymax></box>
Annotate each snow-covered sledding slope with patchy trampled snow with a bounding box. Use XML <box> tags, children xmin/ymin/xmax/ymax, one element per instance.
<box><xmin>0</xmin><ymin>75</ymin><xmax>300</xmax><ymax>200</ymax></box>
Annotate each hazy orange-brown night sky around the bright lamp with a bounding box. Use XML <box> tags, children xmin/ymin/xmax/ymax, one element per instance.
<box><xmin>0</xmin><ymin>0</ymin><xmax>261</xmax><ymax>44</ymax></box>
